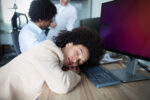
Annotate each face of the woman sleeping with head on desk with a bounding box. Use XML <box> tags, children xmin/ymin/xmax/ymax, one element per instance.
<box><xmin>62</xmin><ymin>42</ymin><xmax>89</xmax><ymax>67</ymax></box>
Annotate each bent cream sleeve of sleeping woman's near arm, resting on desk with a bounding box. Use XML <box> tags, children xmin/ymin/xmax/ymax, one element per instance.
<box><xmin>46</xmin><ymin>57</ymin><xmax>81</xmax><ymax>94</ymax></box>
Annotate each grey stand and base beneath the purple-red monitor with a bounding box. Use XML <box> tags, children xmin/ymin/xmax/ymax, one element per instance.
<box><xmin>110</xmin><ymin>57</ymin><xmax>150</xmax><ymax>82</ymax></box>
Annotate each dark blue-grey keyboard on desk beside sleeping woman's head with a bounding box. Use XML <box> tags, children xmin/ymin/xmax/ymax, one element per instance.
<box><xmin>81</xmin><ymin>66</ymin><xmax>120</xmax><ymax>88</ymax></box>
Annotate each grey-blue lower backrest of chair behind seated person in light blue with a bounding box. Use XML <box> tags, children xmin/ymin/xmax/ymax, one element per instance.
<box><xmin>11</xmin><ymin>31</ymin><xmax>21</xmax><ymax>55</ymax></box>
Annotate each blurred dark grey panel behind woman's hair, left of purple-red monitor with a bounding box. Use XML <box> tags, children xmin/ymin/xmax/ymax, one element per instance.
<box><xmin>80</xmin><ymin>17</ymin><xmax>100</xmax><ymax>32</ymax></box>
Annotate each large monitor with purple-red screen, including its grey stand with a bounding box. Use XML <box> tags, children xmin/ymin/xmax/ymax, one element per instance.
<box><xmin>100</xmin><ymin>0</ymin><xmax>150</xmax><ymax>82</ymax></box>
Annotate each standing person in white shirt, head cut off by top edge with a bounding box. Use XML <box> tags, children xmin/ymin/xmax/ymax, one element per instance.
<box><xmin>47</xmin><ymin>0</ymin><xmax>77</xmax><ymax>40</ymax></box>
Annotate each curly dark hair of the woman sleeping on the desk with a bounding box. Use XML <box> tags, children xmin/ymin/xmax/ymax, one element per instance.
<box><xmin>54</xmin><ymin>27</ymin><xmax>104</xmax><ymax>67</ymax></box>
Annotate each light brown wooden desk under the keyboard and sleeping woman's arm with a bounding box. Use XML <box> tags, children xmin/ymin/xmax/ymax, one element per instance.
<box><xmin>39</xmin><ymin>63</ymin><xmax>150</xmax><ymax>100</ymax></box>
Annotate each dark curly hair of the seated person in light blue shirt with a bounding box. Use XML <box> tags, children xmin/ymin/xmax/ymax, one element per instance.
<box><xmin>28</xmin><ymin>0</ymin><xmax>57</xmax><ymax>22</ymax></box>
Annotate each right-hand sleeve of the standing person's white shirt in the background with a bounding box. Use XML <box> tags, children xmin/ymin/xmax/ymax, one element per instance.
<box><xmin>66</xmin><ymin>8</ymin><xmax>77</xmax><ymax>31</ymax></box>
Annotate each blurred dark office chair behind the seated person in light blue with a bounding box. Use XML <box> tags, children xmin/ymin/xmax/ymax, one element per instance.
<box><xmin>11</xmin><ymin>12</ymin><xmax>28</xmax><ymax>55</ymax></box>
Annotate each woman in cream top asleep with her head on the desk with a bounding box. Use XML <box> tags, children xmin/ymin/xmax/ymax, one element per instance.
<box><xmin>0</xmin><ymin>27</ymin><xmax>103</xmax><ymax>100</ymax></box>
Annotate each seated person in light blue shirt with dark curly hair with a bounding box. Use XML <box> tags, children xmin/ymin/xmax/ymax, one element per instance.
<box><xmin>19</xmin><ymin>0</ymin><xmax>57</xmax><ymax>53</ymax></box>
